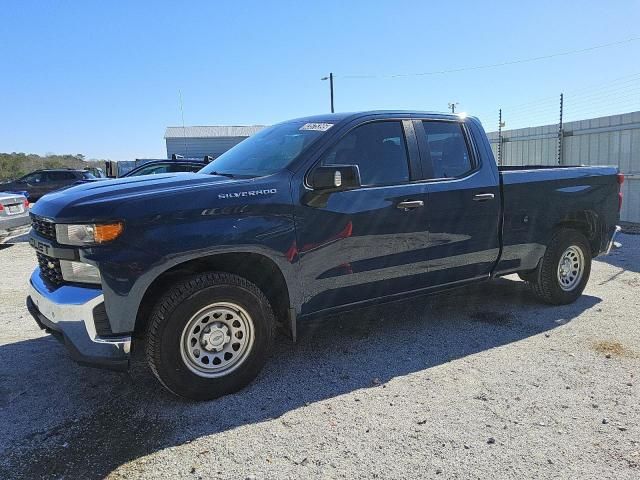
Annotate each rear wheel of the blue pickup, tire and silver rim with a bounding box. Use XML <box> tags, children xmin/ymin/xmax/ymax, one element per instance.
<box><xmin>528</xmin><ymin>230</ymin><xmax>591</xmax><ymax>305</ymax></box>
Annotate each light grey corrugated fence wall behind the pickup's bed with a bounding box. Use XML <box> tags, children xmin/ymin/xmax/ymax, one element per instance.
<box><xmin>488</xmin><ymin>112</ymin><xmax>640</xmax><ymax>223</ymax></box>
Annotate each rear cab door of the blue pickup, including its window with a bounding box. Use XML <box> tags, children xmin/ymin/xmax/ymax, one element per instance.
<box><xmin>414</xmin><ymin>119</ymin><xmax>500</xmax><ymax>287</ymax></box>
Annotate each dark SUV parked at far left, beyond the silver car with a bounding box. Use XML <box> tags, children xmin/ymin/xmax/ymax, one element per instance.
<box><xmin>0</xmin><ymin>168</ymin><xmax>97</xmax><ymax>202</ymax></box>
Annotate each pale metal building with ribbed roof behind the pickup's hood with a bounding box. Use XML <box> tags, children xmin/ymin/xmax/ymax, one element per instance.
<box><xmin>164</xmin><ymin>125</ymin><xmax>265</xmax><ymax>158</ymax></box>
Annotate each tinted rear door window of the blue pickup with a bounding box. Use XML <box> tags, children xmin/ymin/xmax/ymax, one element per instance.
<box><xmin>416</xmin><ymin>120</ymin><xmax>474</xmax><ymax>179</ymax></box>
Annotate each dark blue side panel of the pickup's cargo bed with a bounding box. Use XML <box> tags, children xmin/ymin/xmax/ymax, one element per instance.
<box><xmin>495</xmin><ymin>165</ymin><xmax>618</xmax><ymax>274</ymax></box>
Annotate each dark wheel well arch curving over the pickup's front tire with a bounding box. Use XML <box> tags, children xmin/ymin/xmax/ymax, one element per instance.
<box><xmin>134</xmin><ymin>253</ymin><xmax>290</xmax><ymax>336</ymax></box>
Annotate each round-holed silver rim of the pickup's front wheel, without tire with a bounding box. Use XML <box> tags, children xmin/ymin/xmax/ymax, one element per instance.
<box><xmin>180</xmin><ymin>302</ymin><xmax>254</xmax><ymax>378</ymax></box>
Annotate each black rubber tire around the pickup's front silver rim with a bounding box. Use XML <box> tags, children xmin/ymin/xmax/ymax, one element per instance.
<box><xmin>146</xmin><ymin>272</ymin><xmax>275</xmax><ymax>400</ymax></box>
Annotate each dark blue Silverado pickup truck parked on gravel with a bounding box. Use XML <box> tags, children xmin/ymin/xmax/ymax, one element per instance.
<box><xmin>27</xmin><ymin>112</ymin><xmax>623</xmax><ymax>399</ymax></box>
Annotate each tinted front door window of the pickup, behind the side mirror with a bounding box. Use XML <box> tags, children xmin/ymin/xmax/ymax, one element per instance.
<box><xmin>320</xmin><ymin>121</ymin><xmax>409</xmax><ymax>186</ymax></box>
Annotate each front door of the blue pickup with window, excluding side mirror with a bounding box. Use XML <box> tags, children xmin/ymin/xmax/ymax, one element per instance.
<box><xmin>296</xmin><ymin>119</ymin><xmax>428</xmax><ymax>314</ymax></box>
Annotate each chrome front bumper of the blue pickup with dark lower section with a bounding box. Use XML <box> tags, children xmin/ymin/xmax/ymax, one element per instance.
<box><xmin>27</xmin><ymin>268</ymin><xmax>131</xmax><ymax>371</ymax></box>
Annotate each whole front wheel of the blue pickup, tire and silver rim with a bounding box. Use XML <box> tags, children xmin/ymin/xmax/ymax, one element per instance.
<box><xmin>146</xmin><ymin>273</ymin><xmax>275</xmax><ymax>400</ymax></box>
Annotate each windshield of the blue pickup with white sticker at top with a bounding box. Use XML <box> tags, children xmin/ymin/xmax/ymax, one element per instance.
<box><xmin>200</xmin><ymin>122</ymin><xmax>332</xmax><ymax>176</ymax></box>
